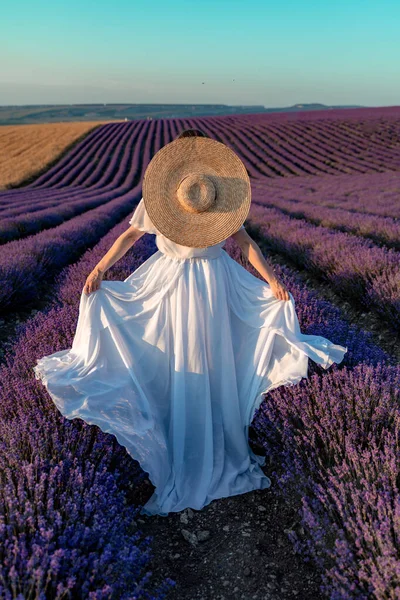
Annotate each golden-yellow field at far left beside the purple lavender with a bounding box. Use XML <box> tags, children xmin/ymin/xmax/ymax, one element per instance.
<box><xmin>0</xmin><ymin>121</ymin><xmax>115</xmax><ymax>189</ymax></box>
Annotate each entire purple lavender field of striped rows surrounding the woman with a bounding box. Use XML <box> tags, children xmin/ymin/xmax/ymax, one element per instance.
<box><xmin>0</xmin><ymin>108</ymin><xmax>400</xmax><ymax>600</ymax></box>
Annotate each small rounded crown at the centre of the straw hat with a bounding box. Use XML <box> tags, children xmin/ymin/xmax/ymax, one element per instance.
<box><xmin>176</xmin><ymin>173</ymin><xmax>217</xmax><ymax>213</ymax></box>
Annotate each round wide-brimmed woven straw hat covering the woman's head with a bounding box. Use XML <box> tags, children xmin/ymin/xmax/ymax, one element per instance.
<box><xmin>142</xmin><ymin>136</ymin><xmax>251</xmax><ymax>248</ymax></box>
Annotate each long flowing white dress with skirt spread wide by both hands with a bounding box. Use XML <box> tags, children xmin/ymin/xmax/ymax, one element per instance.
<box><xmin>33</xmin><ymin>199</ymin><xmax>347</xmax><ymax>516</ymax></box>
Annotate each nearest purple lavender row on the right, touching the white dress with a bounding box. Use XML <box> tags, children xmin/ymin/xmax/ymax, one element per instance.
<box><xmin>225</xmin><ymin>240</ymin><xmax>400</xmax><ymax>600</ymax></box>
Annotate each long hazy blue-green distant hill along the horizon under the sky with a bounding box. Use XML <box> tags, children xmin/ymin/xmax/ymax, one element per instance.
<box><xmin>0</xmin><ymin>103</ymin><xmax>363</xmax><ymax>125</ymax></box>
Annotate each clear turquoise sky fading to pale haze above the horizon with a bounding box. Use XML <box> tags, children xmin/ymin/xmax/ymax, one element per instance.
<box><xmin>0</xmin><ymin>0</ymin><xmax>400</xmax><ymax>108</ymax></box>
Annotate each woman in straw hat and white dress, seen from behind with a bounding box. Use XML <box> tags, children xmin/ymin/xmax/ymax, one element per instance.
<box><xmin>34</xmin><ymin>130</ymin><xmax>347</xmax><ymax>516</ymax></box>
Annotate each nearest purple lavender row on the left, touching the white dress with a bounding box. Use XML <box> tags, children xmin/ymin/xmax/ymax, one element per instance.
<box><xmin>0</xmin><ymin>220</ymin><xmax>175</xmax><ymax>600</ymax></box>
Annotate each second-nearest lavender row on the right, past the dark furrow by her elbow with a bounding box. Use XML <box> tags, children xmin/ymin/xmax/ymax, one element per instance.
<box><xmin>244</xmin><ymin>203</ymin><xmax>400</xmax><ymax>330</ymax></box>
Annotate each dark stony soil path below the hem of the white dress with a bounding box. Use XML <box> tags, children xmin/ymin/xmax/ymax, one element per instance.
<box><xmin>131</xmin><ymin>466</ymin><xmax>325</xmax><ymax>600</ymax></box>
